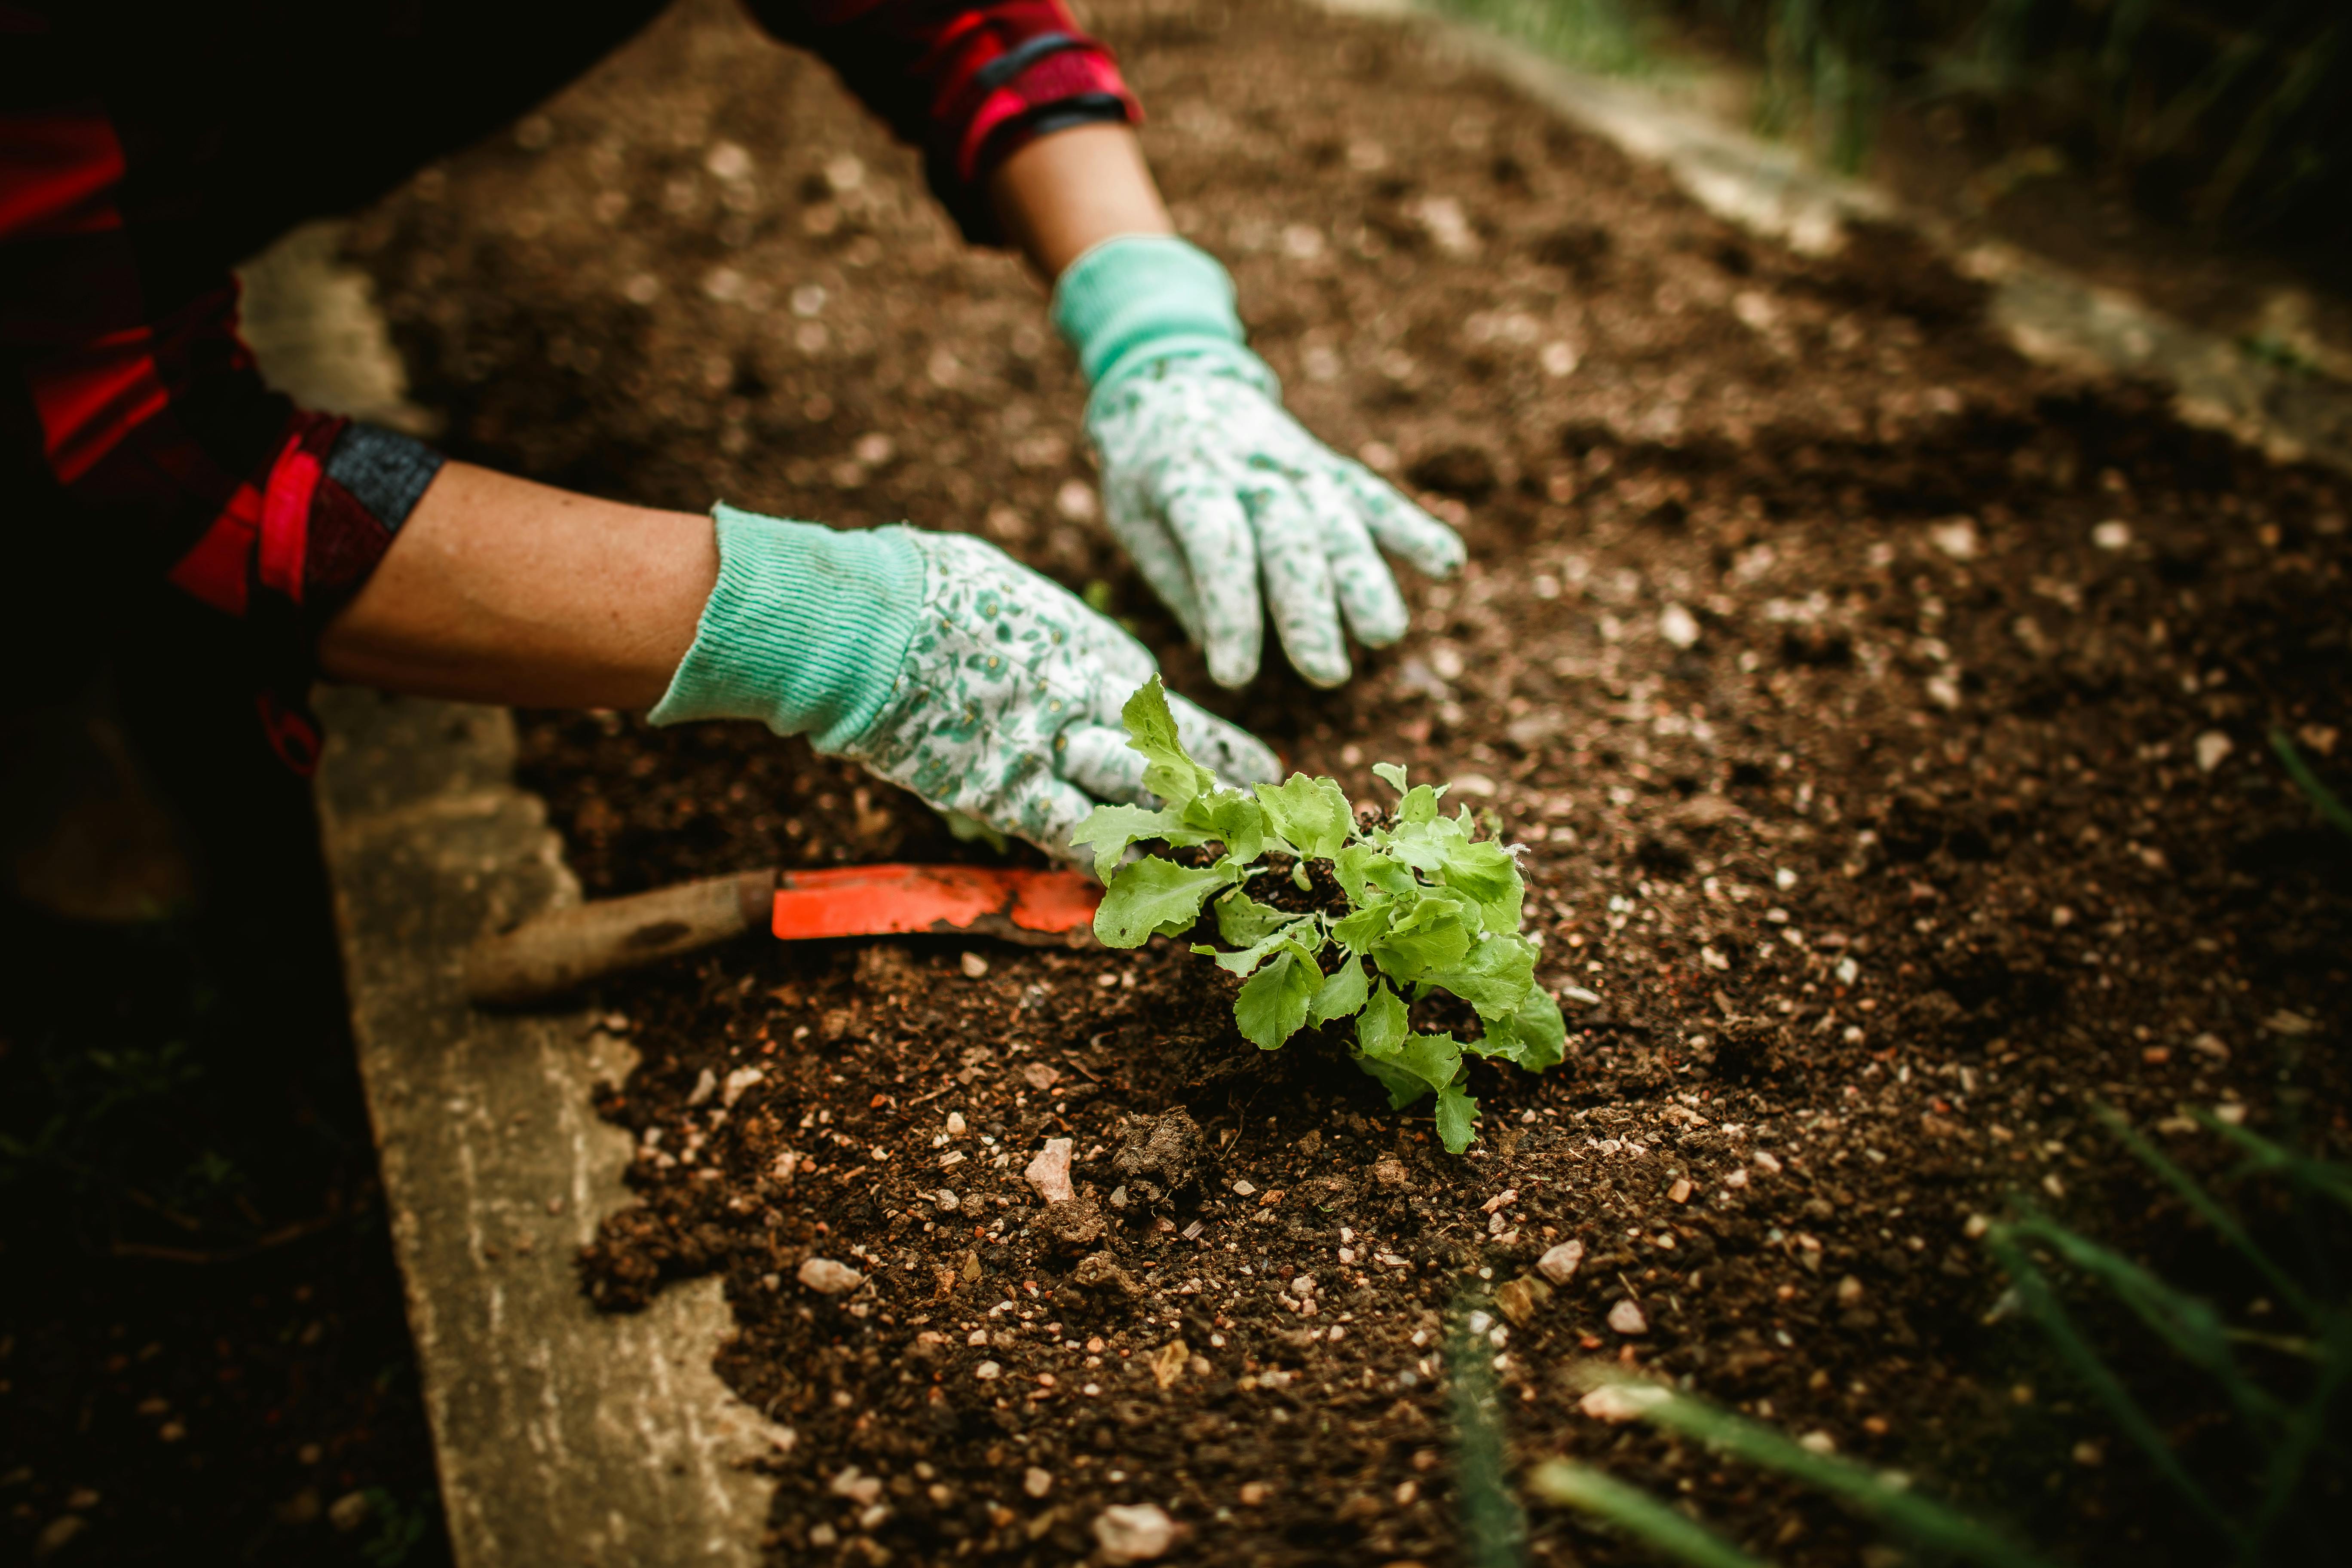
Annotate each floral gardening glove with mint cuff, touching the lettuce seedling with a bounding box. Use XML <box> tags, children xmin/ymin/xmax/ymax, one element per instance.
<box><xmin>649</xmin><ymin>503</ymin><xmax>1280</xmax><ymax>858</ymax></box>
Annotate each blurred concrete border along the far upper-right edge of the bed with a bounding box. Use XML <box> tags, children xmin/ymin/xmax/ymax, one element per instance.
<box><xmin>1315</xmin><ymin>0</ymin><xmax>2352</xmax><ymax>472</ymax></box>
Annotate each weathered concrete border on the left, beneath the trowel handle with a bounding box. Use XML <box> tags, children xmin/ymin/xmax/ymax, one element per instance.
<box><xmin>245</xmin><ymin>226</ymin><xmax>793</xmax><ymax>1568</ymax></box>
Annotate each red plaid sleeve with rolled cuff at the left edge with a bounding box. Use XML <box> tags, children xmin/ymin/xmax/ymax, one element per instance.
<box><xmin>0</xmin><ymin>84</ymin><xmax>438</xmax><ymax>766</ymax></box>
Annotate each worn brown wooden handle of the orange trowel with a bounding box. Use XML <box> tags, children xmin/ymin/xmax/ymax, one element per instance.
<box><xmin>466</xmin><ymin>870</ymin><xmax>776</xmax><ymax>1006</ymax></box>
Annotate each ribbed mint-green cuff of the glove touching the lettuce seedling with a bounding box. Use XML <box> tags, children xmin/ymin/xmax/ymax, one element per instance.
<box><xmin>647</xmin><ymin>501</ymin><xmax>922</xmax><ymax>750</ymax></box>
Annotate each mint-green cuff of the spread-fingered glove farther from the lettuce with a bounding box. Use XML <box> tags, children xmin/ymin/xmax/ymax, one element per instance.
<box><xmin>1054</xmin><ymin>235</ymin><xmax>1275</xmax><ymax>395</ymax></box>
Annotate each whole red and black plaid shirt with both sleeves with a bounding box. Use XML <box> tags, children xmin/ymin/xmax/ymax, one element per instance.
<box><xmin>0</xmin><ymin>0</ymin><xmax>1138</xmax><ymax>771</ymax></box>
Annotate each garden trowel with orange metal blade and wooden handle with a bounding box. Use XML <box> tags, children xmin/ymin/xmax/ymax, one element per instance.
<box><xmin>466</xmin><ymin>865</ymin><xmax>1103</xmax><ymax>1006</ymax></box>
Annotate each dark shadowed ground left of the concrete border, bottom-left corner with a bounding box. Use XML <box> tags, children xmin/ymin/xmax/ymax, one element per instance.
<box><xmin>0</xmin><ymin>903</ymin><xmax>449</xmax><ymax>1568</ymax></box>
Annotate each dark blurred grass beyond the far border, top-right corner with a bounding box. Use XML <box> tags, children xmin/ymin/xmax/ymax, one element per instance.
<box><xmin>1435</xmin><ymin>0</ymin><xmax>2352</xmax><ymax>240</ymax></box>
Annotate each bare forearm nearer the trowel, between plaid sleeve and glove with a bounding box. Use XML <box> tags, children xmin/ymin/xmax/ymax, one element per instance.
<box><xmin>318</xmin><ymin>463</ymin><xmax>717</xmax><ymax>707</ymax></box>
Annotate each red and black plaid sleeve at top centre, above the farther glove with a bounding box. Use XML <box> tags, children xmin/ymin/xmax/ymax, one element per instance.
<box><xmin>746</xmin><ymin>0</ymin><xmax>1143</xmax><ymax>245</ymax></box>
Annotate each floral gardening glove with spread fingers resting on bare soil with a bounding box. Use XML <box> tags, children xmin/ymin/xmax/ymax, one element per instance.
<box><xmin>1054</xmin><ymin>235</ymin><xmax>1463</xmax><ymax>686</ymax></box>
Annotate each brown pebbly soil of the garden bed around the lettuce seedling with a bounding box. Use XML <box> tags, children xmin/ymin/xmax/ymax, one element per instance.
<box><xmin>355</xmin><ymin>0</ymin><xmax>2352</xmax><ymax>1563</ymax></box>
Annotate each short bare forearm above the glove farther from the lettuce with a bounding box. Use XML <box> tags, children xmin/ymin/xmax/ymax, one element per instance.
<box><xmin>988</xmin><ymin>125</ymin><xmax>1176</xmax><ymax>282</ymax></box>
